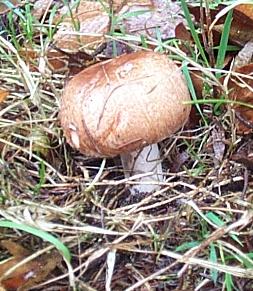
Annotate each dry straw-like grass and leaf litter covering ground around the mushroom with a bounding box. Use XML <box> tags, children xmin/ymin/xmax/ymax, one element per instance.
<box><xmin>0</xmin><ymin>0</ymin><xmax>253</xmax><ymax>290</ymax></box>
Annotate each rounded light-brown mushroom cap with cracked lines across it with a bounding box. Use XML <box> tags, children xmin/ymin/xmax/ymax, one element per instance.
<box><xmin>60</xmin><ymin>51</ymin><xmax>191</xmax><ymax>157</ymax></box>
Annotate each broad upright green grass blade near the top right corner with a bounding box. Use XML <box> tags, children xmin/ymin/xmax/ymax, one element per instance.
<box><xmin>216</xmin><ymin>10</ymin><xmax>233</xmax><ymax>78</ymax></box>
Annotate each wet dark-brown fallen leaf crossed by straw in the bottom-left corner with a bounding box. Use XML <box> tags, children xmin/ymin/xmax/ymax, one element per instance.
<box><xmin>0</xmin><ymin>240</ymin><xmax>62</xmax><ymax>291</ymax></box>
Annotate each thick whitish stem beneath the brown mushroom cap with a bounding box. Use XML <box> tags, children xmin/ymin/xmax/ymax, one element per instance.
<box><xmin>121</xmin><ymin>144</ymin><xmax>163</xmax><ymax>194</ymax></box>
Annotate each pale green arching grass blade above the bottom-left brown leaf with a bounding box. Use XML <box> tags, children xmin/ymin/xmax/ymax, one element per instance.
<box><xmin>0</xmin><ymin>220</ymin><xmax>71</xmax><ymax>262</ymax></box>
